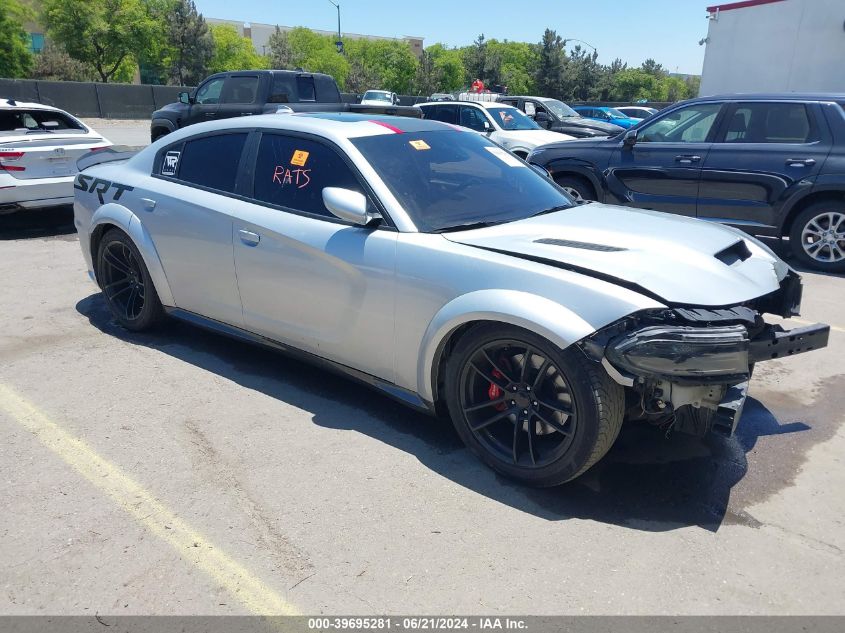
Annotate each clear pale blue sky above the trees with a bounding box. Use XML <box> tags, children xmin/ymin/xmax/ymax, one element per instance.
<box><xmin>194</xmin><ymin>0</ymin><xmax>717</xmax><ymax>75</ymax></box>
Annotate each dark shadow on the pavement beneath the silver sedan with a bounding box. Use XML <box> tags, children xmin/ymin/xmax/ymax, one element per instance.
<box><xmin>76</xmin><ymin>294</ymin><xmax>810</xmax><ymax>532</ymax></box>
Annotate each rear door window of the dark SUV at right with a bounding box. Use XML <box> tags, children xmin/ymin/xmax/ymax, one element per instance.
<box><xmin>725</xmin><ymin>103</ymin><xmax>818</xmax><ymax>143</ymax></box>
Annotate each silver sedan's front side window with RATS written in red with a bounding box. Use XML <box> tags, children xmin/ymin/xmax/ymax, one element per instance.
<box><xmin>253</xmin><ymin>133</ymin><xmax>364</xmax><ymax>218</ymax></box>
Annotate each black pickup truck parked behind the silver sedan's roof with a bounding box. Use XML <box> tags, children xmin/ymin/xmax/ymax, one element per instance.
<box><xmin>150</xmin><ymin>70</ymin><xmax>421</xmax><ymax>141</ymax></box>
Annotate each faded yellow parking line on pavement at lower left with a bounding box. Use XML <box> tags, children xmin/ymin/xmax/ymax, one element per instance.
<box><xmin>0</xmin><ymin>384</ymin><xmax>299</xmax><ymax>615</ymax></box>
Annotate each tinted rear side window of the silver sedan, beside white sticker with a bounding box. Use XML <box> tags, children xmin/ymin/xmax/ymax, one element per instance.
<box><xmin>176</xmin><ymin>132</ymin><xmax>247</xmax><ymax>193</ymax></box>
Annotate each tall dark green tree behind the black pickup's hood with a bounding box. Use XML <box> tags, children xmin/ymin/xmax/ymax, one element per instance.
<box><xmin>164</xmin><ymin>0</ymin><xmax>214</xmax><ymax>86</ymax></box>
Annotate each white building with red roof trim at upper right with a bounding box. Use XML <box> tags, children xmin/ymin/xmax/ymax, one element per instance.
<box><xmin>700</xmin><ymin>0</ymin><xmax>845</xmax><ymax>96</ymax></box>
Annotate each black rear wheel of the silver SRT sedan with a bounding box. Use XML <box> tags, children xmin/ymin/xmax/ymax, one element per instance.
<box><xmin>97</xmin><ymin>229</ymin><xmax>164</xmax><ymax>332</ymax></box>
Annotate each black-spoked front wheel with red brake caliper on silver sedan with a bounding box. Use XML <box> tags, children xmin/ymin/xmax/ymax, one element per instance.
<box><xmin>445</xmin><ymin>325</ymin><xmax>625</xmax><ymax>486</ymax></box>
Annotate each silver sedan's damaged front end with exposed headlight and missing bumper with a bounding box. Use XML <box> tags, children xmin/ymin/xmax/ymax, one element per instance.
<box><xmin>579</xmin><ymin>273</ymin><xmax>830</xmax><ymax>436</ymax></box>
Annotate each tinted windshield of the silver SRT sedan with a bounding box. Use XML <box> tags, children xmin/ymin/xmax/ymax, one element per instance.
<box><xmin>352</xmin><ymin>130</ymin><xmax>572</xmax><ymax>233</ymax></box>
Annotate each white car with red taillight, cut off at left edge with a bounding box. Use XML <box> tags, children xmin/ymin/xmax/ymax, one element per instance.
<box><xmin>0</xmin><ymin>99</ymin><xmax>111</xmax><ymax>214</ymax></box>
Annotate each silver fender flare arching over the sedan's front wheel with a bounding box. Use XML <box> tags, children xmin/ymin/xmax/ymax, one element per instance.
<box><xmin>417</xmin><ymin>288</ymin><xmax>596</xmax><ymax>402</ymax></box>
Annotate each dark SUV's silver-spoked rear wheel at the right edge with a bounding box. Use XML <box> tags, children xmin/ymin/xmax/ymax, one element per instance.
<box><xmin>789</xmin><ymin>200</ymin><xmax>845</xmax><ymax>273</ymax></box>
